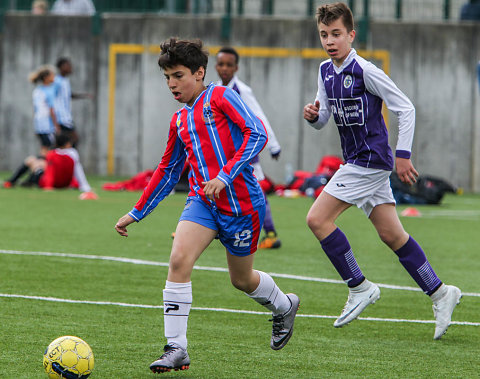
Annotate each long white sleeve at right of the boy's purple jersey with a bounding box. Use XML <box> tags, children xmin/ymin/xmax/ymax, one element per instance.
<box><xmin>364</xmin><ymin>63</ymin><xmax>415</xmax><ymax>158</ymax></box>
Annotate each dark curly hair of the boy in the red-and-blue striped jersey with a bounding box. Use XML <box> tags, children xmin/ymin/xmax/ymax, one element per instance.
<box><xmin>158</xmin><ymin>37</ymin><xmax>208</xmax><ymax>74</ymax></box>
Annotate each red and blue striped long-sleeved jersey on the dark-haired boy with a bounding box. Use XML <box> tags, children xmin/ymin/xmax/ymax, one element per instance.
<box><xmin>129</xmin><ymin>83</ymin><xmax>267</xmax><ymax>221</ymax></box>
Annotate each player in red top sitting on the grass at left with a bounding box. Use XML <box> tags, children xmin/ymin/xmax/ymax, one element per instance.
<box><xmin>3</xmin><ymin>133</ymin><xmax>97</xmax><ymax>200</ymax></box>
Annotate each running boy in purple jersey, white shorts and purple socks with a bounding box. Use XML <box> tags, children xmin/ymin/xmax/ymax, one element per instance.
<box><xmin>303</xmin><ymin>3</ymin><xmax>462</xmax><ymax>339</ymax></box>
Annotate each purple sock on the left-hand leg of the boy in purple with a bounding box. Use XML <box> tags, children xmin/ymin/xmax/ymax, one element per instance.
<box><xmin>320</xmin><ymin>228</ymin><xmax>365</xmax><ymax>287</ymax></box>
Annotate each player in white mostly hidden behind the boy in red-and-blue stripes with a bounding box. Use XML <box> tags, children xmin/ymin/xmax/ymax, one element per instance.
<box><xmin>215</xmin><ymin>46</ymin><xmax>281</xmax><ymax>249</ymax></box>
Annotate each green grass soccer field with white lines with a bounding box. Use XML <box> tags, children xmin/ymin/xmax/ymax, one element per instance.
<box><xmin>0</xmin><ymin>173</ymin><xmax>480</xmax><ymax>378</ymax></box>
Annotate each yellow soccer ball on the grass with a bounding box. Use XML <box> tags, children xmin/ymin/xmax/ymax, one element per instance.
<box><xmin>43</xmin><ymin>336</ymin><xmax>95</xmax><ymax>379</ymax></box>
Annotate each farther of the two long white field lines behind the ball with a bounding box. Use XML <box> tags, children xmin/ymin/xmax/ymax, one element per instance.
<box><xmin>0</xmin><ymin>249</ymin><xmax>480</xmax><ymax>297</ymax></box>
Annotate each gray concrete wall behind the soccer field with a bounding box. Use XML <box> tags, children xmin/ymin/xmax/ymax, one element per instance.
<box><xmin>0</xmin><ymin>14</ymin><xmax>480</xmax><ymax>191</ymax></box>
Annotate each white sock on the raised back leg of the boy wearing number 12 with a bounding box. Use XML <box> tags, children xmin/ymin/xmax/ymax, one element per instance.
<box><xmin>246</xmin><ymin>270</ymin><xmax>292</xmax><ymax>316</ymax></box>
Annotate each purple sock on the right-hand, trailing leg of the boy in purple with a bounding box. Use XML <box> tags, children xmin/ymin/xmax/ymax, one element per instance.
<box><xmin>395</xmin><ymin>237</ymin><xmax>442</xmax><ymax>295</ymax></box>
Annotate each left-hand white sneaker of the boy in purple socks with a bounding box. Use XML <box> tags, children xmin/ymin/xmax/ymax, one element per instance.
<box><xmin>333</xmin><ymin>279</ymin><xmax>380</xmax><ymax>328</ymax></box>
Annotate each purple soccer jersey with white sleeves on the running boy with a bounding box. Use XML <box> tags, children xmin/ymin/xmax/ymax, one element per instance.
<box><xmin>311</xmin><ymin>49</ymin><xmax>415</xmax><ymax>171</ymax></box>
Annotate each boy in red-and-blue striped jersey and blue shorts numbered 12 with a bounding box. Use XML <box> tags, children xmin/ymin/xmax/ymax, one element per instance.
<box><xmin>115</xmin><ymin>38</ymin><xmax>299</xmax><ymax>373</ymax></box>
